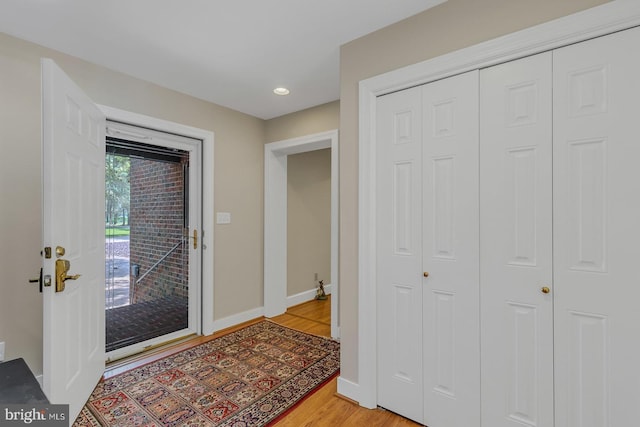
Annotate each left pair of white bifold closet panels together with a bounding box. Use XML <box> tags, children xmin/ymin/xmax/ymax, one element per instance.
<box><xmin>376</xmin><ymin>71</ymin><xmax>480</xmax><ymax>427</ymax></box>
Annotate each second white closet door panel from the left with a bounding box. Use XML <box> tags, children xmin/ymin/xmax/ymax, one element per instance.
<box><xmin>422</xmin><ymin>71</ymin><xmax>480</xmax><ymax>427</ymax></box>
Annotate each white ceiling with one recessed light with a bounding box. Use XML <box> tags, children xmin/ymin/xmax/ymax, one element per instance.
<box><xmin>0</xmin><ymin>0</ymin><xmax>446</xmax><ymax>119</ymax></box>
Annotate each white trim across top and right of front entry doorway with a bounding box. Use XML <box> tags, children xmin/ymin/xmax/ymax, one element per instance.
<box><xmin>98</xmin><ymin>105</ymin><xmax>214</xmax><ymax>335</ymax></box>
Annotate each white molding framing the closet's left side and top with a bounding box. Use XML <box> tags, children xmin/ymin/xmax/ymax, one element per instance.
<box><xmin>356</xmin><ymin>0</ymin><xmax>640</xmax><ymax>408</ymax></box>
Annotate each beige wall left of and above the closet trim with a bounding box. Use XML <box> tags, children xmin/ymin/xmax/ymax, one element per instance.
<box><xmin>340</xmin><ymin>0</ymin><xmax>607</xmax><ymax>383</ymax></box>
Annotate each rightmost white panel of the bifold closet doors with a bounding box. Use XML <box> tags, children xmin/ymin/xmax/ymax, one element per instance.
<box><xmin>554</xmin><ymin>28</ymin><xmax>640</xmax><ymax>427</ymax></box>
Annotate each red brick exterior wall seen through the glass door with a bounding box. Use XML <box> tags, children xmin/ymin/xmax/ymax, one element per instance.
<box><xmin>130</xmin><ymin>157</ymin><xmax>189</xmax><ymax>304</ymax></box>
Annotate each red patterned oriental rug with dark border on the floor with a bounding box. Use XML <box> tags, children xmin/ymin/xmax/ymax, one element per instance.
<box><xmin>74</xmin><ymin>321</ymin><xmax>340</xmax><ymax>427</ymax></box>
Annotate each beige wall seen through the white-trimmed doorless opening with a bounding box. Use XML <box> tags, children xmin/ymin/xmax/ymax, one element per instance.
<box><xmin>287</xmin><ymin>148</ymin><xmax>331</xmax><ymax>296</ymax></box>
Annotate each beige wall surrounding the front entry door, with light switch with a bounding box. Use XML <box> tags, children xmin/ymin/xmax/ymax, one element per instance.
<box><xmin>0</xmin><ymin>34</ymin><xmax>265</xmax><ymax>374</ymax></box>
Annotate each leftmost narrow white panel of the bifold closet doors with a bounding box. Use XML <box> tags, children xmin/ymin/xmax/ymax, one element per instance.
<box><xmin>376</xmin><ymin>88</ymin><xmax>423</xmax><ymax>422</ymax></box>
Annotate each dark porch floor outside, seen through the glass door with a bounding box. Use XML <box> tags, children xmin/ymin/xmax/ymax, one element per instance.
<box><xmin>106</xmin><ymin>297</ymin><xmax>189</xmax><ymax>352</ymax></box>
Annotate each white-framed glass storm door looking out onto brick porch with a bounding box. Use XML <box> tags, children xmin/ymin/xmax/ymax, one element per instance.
<box><xmin>105</xmin><ymin>122</ymin><xmax>201</xmax><ymax>360</ymax></box>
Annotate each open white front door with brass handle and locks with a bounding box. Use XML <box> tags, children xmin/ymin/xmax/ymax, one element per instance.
<box><xmin>42</xmin><ymin>59</ymin><xmax>106</xmax><ymax>423</ymax></box>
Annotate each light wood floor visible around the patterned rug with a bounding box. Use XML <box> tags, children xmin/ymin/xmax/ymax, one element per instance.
<box><xmin>105</xmin><ymin>299</ymin><xmax>420</xmax><ymax>427</ymax></box>
